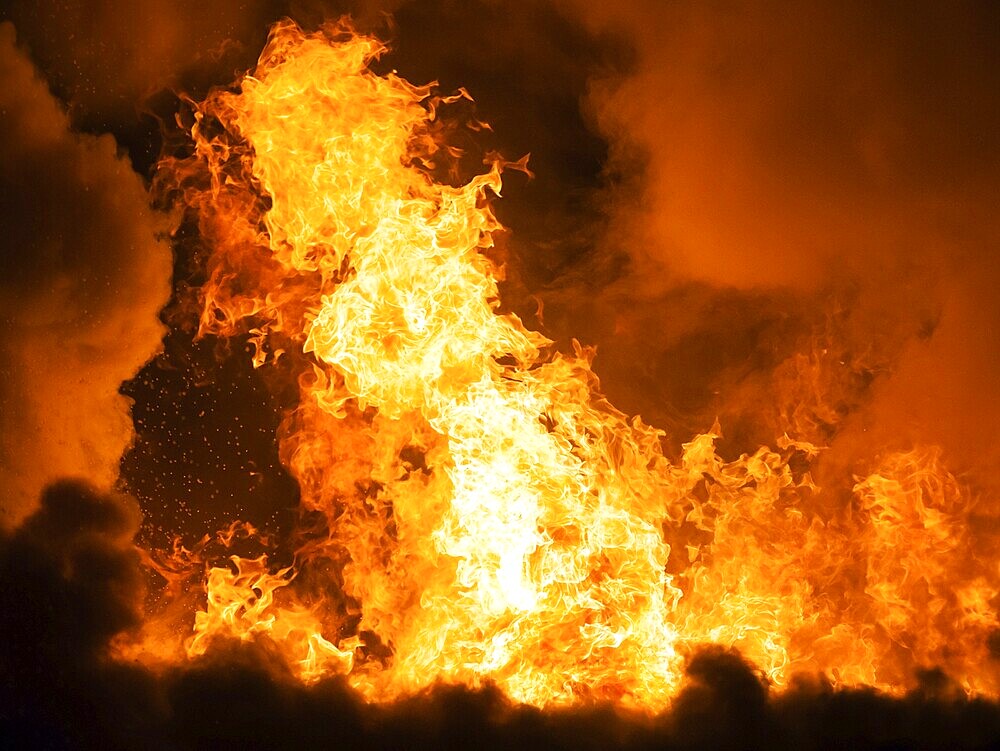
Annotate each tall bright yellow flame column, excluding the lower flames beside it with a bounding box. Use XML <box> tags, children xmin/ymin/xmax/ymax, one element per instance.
<box><xmin>187</xmin><ymin>20</ymin><xmax>676</xmax><ymax>703</ymax></box>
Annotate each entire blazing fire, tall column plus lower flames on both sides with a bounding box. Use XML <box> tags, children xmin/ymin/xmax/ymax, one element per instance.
<box><xmin>123</xmin><ymin>22</ymin><xmax>998</xmax><ymax>711</ymax></box>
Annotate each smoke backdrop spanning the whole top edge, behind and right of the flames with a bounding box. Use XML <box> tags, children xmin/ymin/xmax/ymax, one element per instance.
<box><xmin>9</xmin><ymin>0</ymin><xmax>1000</xmax><ymax>484</ymax></box>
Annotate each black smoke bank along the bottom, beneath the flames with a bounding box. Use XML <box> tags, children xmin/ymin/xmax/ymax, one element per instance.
<box><xmin>7</xmin><ymin>481</ymin><xmax>1000</xmax><ymax>751</ymax></box>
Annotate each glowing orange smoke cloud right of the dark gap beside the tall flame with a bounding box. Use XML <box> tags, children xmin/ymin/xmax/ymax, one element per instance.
<box><xmin>562</xmin><ymin>0</ymin><xmax>1000</xmax><ymax>483</ymax></box>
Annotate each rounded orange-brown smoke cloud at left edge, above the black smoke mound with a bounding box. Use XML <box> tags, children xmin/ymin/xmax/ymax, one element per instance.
<box><xmin>0</xmin><ymin>24</ymin><xmax>170</xmax><ymax>525</ymax></box>
